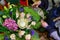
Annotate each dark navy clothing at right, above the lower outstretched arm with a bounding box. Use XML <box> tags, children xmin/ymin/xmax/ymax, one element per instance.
<box><xmin>47</xmin><ymin>7</ymin><xmax>60</xmax><ymax>27</ymax></box>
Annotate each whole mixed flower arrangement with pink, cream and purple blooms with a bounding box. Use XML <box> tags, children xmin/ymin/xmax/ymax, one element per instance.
<box><xmin>0</xmin><ymin>3</ymin><xmax>46</xmax><ymax>40</ymax></box>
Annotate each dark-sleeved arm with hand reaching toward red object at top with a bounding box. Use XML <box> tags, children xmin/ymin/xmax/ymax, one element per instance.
<box><xmin>32</xmin><ymin>0</ymin><xmax>48</xmax><ymax>9</ymax></box>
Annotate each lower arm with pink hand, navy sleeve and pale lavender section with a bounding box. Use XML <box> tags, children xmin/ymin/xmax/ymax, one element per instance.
<box><xmin>41</xmin><ymin>20</ymin><xmax>60</xmax><ymax>40</ymax></box>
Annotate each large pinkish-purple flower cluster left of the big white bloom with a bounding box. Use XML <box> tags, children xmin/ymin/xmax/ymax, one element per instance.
<box><xmin>3</xmin><ymin>18</ymin><xmax>18</xmax><ymax>31</ymax></box>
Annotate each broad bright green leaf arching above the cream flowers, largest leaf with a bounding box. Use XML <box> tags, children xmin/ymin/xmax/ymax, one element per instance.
<box><xmin>24</xmin><ymin>7</ymin><xmax>40</xmax><ymax>21</ymax></box>
